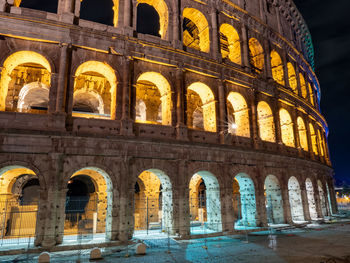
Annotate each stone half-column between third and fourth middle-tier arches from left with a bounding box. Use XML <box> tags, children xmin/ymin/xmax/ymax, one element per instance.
<box><xmin>175</xmin><ymin>68</ymin><xmax>188</xmax><ymax>141</ymax></box>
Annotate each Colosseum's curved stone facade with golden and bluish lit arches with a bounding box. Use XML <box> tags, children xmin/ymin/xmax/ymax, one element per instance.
<box><xmin>0</xmin><ymin>0</ymin><xmax>337</xmax><ymax>248</ymax></box>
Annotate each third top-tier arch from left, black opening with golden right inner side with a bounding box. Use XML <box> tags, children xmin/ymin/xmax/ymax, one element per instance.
<box><xmin>136</xmin><ymin>0</ymin><xmax>169</xmax><ymax>39</ymax></box>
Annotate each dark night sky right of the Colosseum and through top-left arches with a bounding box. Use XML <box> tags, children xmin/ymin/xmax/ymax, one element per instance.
<box><xmin>23</xmin><ymin>0</ymin><xmax>350</xmax><ymax>184</ymax></box>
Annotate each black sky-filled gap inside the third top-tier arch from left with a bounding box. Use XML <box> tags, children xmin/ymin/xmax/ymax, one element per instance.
<box><xmin>136</xmin><ymin>4</ymin><xmax>160</xmax><ymax>37</ymax></box>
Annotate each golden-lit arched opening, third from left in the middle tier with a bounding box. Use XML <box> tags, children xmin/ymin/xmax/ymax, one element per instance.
<box><xmin>135</xmin><ymin>72</ymin><xmax>172</xmax><ymax>125</ymax></box>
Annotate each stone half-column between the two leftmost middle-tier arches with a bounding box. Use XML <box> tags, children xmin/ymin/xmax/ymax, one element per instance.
<box><xmin>56</xmin><ymin>43</ymin><xmax>69</xmax><ymax>113</ymax></box>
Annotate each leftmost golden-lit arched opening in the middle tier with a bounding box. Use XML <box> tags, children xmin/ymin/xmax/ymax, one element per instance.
<box><xmin>0</xmin><ymin>51</ymin><xmax>51</xmax><ymax>114</ymax></box>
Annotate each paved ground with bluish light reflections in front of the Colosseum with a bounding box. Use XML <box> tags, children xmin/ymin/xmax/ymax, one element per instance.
<box><xmin>0</xmin><ymin>222</ymin><xmax>350</xmax><ymax>263</ymax></box>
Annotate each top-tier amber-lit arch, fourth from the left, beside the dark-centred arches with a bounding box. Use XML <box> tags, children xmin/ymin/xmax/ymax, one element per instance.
<box><xmin>182</xmin><ymin>8</ymin><xmax>210</xmax><ymax>53</ymax></box>
